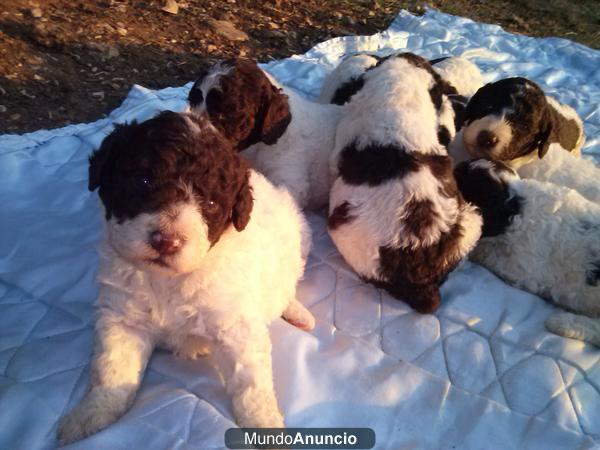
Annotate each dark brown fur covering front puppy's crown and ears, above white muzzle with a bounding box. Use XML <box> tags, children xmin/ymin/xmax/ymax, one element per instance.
<box><xmin>89</xmin><ymin>111</ymin><xmax>253</xmax><ymax>244</ymax></box>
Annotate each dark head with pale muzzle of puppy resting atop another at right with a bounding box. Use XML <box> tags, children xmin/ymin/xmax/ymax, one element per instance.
<box><xmin>463</xmin><ymin>77</ymin><xmax>553</xmax><ymax>162</ymax></box>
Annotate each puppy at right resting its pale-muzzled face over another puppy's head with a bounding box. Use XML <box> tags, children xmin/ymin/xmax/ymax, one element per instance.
<box><xmin>449</xmin><ymin>77</ymin><xmax>600</xmax><ymax>202</ymax></box>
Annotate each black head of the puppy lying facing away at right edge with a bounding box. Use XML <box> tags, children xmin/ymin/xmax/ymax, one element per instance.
<box><xmin>454</xmin><ymin>159</ymin><xmax>521</xmax><ymax>237</ymax></box>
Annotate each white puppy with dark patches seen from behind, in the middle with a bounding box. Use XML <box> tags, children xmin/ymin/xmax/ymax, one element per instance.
<box><xmin>328</xmin><ymin>53</ymin><xmax>481</xmax><ymax>313</ymax></box>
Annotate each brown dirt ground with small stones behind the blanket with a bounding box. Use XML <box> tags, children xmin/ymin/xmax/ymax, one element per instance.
<box><xmin>0</xmin><ymin>0</ymin><xmax>600</xmax><ymax>133</ymax></box>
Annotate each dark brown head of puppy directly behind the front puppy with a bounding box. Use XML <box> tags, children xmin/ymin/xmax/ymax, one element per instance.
<box><xmin>188</xmin><ymin>59</ymin><xmax>292</xmax><ymax>151</ymax></box>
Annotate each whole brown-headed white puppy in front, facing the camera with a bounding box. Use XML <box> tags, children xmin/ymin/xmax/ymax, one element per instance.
<box><xmin>58</xmin><ymin>112</ymin><xmax>314</xmax><ymax>444</ymax></box>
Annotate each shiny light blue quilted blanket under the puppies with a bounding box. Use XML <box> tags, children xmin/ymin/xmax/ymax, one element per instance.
<box><xmin>0</xmin><ymin>10</ymin><xmax>600</xmax><ymax>450</ymax></box>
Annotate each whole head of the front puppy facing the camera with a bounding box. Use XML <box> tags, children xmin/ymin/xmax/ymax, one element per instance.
<box><xmin>89</xmin><ymin>111</ymin><xmax>253</xmax><ymax>275</ymax></box>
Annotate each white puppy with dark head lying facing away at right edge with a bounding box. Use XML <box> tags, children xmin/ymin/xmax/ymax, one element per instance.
<box><xmin>455</xmin><ymin>159</ymin><xmax>600</xmax><ymax>346</ymax></box>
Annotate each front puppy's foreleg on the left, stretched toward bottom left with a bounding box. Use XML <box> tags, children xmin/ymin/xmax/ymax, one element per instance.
<box><xmin>58</xmin><ymin>319</ymin><xmax>152</xmax><ymax>445</ymax></box>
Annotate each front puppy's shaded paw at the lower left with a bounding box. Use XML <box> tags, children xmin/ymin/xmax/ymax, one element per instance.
<box><xmin>58</xmin><ymin>389</ymin><xmax>127</xmax><ymax>445</ymax></box>
